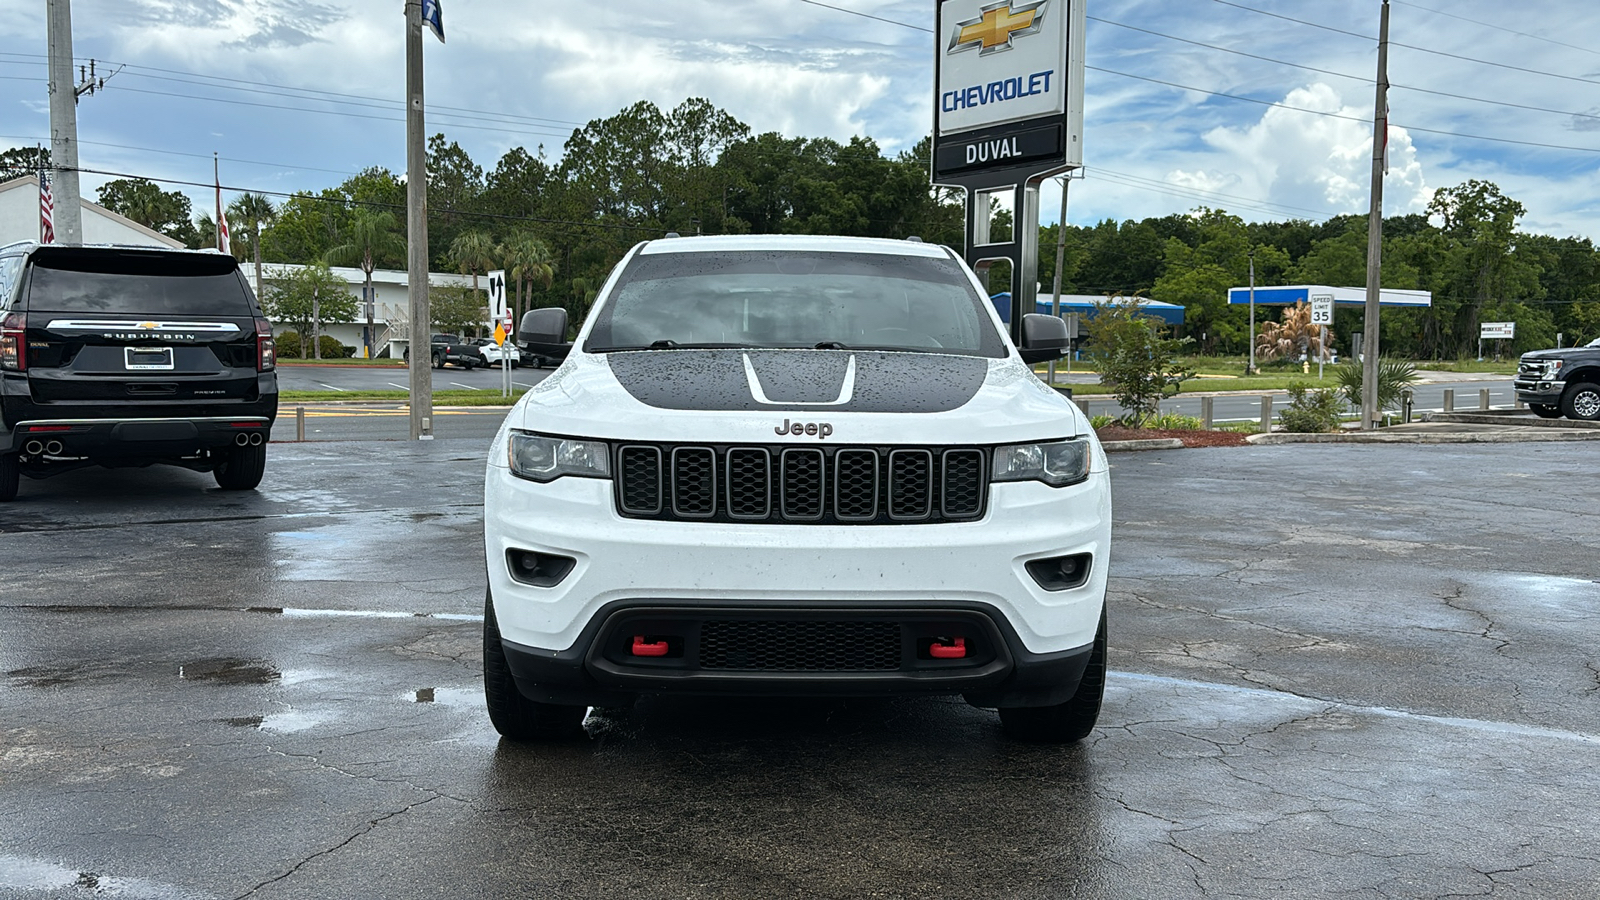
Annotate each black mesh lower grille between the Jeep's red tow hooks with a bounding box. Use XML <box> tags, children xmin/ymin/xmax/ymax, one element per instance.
<box><xmin>699</xmin><ymin>620</ymin><xmax>902</xmax><ymax>673</ymax></box>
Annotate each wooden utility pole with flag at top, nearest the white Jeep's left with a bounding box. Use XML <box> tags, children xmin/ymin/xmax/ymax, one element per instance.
<box><xmin>405</xmin><ymin>0</ymin><xmax>434</xmax><ymax>440</ymax></box>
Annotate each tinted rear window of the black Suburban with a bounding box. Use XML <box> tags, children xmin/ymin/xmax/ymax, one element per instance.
<box><xmin>27</xmin><ymin>251</ymin><xmax>254</xmax><ymax>315</ymax></box>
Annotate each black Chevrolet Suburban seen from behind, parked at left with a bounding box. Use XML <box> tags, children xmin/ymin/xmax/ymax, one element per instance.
<box><xmin>0</xmin><ymin>242</ymin><xmax>278</xmax><ymax>501</ymax></box>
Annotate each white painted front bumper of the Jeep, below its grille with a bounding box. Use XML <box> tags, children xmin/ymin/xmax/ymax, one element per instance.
<box><xmin>483</xmin><ymin>464</ymin><xmax>1110</xmax><ymax>658</ymax></box>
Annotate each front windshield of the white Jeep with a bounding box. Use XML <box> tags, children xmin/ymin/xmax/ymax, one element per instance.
<box><xmin>584</xmin><ymin>251</ymin><xmax>1006</xmax><ymax>357</ymax></box>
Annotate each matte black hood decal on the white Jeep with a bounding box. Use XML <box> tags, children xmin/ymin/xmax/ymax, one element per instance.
<box><xmin>606</xmin><ymin>349</ymin><xmax>989</xmax><ymax>413</ymax></box>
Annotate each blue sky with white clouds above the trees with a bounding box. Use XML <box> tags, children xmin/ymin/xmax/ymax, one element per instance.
<box><xmin>0</xmin><ymin>0</ymin><xmax>1600</xmax><ymax>239</ymax></box>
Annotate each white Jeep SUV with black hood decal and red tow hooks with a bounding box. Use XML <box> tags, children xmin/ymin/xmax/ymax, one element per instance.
<box><xmin>483</xmin><ymin>235</ymin><xmax>1110</xmax><ymax>741</ymax></box>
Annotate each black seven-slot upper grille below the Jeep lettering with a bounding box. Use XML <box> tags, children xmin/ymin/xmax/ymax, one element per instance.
<box><xmin>614</xmin><ymin>444</ymin><xmax>989</xmax><ymax>525</ymax></box>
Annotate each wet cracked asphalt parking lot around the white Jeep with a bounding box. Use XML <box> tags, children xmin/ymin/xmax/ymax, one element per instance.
<box><xmin>0</xmin><ymin>440</ymin><xmax>1600</xmax><ymax>898</ymax></box>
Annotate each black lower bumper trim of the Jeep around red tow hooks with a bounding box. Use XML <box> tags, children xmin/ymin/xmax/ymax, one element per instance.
<box><xmin>502</xmin><ymin>601</ymin><xmax>1093</xmax><ymax>706</ymax></box>
